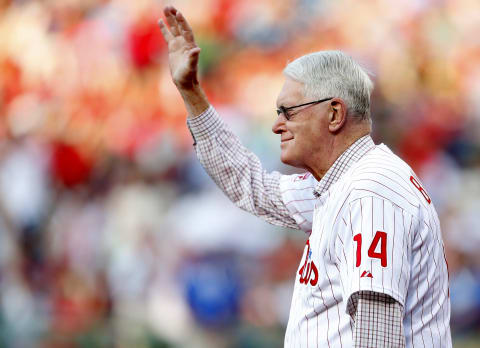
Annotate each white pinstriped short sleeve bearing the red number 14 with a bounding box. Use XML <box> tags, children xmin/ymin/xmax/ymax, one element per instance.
<box><xmin>335</xmin><ymin>196</ymin><xmax>414</xmax><ymax>306</ymax></box>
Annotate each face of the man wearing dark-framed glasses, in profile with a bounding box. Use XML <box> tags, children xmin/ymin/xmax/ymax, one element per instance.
<box><xmin>272</xmin><ymin>78</ymin><xmax>329</xmax><ymax>170</ymax></box>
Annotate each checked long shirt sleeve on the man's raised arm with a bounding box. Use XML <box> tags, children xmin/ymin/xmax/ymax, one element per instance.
<box><xmin>187</xmin><ymin>106</ymin><xmax>301</xmax><ymax>229</ymax></box>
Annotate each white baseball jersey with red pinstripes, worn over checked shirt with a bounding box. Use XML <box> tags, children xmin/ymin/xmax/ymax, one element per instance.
<box><xmin>280</xmin><ymin>136</ymin><xmax>451</xmax><ymax>347</ymax></box>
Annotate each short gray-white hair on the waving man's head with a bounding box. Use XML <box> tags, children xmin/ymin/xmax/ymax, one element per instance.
<box><xmin>283</xmin><ymin>51</ymin><xmax>373</xmax><ymax>120</ymax></box>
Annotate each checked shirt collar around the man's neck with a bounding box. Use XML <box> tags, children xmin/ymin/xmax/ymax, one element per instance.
<box><xmin>313</xmin><ymin>135</ymin><xmax>375</xmax><ymax>198</ymax></box>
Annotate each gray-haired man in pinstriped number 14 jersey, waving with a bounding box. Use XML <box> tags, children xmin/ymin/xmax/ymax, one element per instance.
<box><xmin>160</xmin><ymin>7</ymin><xmax>451</xmax><ymax>347</ymax></box>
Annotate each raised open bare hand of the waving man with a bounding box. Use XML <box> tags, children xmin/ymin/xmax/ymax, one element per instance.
<box><xmin>158</xmin><ymin>6</ymin><xmax>200</xmax><ymax>92</ymax></box>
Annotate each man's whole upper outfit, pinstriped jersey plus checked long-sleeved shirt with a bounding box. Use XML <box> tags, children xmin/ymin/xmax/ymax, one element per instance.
<box><xmin>188</xmin><ymin>107</ymin><xmax>451</xmax><ymax>347</ymax></box>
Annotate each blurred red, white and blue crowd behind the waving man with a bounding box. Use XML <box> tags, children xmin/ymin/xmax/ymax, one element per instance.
<box><xmin>0</xmin><ymin>0</ymin><xmax>480</xmax><ymax>348</ymax></box>
